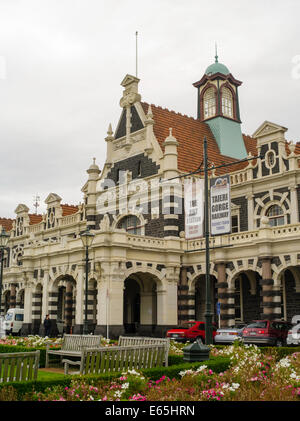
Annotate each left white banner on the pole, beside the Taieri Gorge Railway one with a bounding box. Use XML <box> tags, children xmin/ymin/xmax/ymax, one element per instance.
<box><xmin>184</xmin><ymin>179</ymin><xmax>204</xmax><ymax>240</ymax></box>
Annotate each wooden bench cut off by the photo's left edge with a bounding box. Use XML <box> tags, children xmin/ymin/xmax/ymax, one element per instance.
<box><xmin>0</xmin><ymin>351</ymin><xmax>40</xmax><ymax>383</ymax></box>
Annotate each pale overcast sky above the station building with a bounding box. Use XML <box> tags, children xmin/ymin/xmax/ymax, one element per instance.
<box><xmin>0</xmin><ymin>0</ymin><xmax>300</xmax><ymax>218</ymax></box>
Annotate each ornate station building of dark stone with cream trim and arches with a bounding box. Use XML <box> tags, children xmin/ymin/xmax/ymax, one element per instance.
<box><xmin>0</xmin><ymin>60</ymin><xmax>300</xmax><ymax>337</ymax></box>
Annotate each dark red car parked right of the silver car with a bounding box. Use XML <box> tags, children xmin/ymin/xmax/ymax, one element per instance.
<box><xmin>242</xmin><ymin>320</ymin><xmax>292</xmax><ymax>346</ymax></box>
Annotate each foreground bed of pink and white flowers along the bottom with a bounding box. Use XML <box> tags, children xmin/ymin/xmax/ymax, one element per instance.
<box><xmin>0</xmin><ymin>344</ymin><xmax>300</xmax><ymax>401</ymax></box>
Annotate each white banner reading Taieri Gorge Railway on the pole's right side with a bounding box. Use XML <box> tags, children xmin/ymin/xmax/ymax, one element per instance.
<box><xmin>210</xmin><ymin>175</ymin><xmax>231</xmax><ymax>235</ymax></box>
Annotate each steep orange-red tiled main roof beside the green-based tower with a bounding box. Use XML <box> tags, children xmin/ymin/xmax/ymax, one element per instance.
<box><xmin>141</xmin><ymin>102</ymin><xmax>257</xmax><ymax>174</ymax></box>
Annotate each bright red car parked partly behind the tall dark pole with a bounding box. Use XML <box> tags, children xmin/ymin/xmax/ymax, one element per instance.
<box><xmin>167</xmin><ymin>321</ymin><xmax>217</xmax><ymax>343</ymax></box>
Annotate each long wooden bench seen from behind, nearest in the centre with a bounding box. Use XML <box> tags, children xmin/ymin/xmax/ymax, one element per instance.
<box><xmin>62</xmin><ymin>344</ymin><xmax>165</xmax><ymax>375</ymax></box>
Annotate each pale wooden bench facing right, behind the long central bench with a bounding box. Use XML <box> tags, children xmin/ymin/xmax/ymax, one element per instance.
<box><xmin>45</xmin><ymin>334</ymin><xmax>102</xmax><ymax>368</ymax></box>
